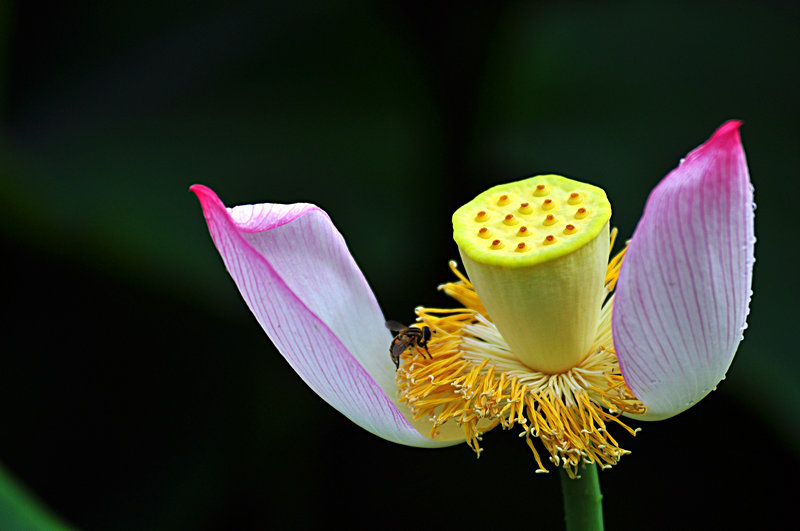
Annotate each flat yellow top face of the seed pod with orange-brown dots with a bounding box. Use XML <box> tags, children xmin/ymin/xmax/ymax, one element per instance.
<box><xmin>453</xmin><ymin>175</ymin><xmax>611</xmax><ymax>267</ymax></box>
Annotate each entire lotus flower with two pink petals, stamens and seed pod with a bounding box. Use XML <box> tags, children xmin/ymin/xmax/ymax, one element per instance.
<box><xmin>191</xmin><ymin>121</ymin><xmax>755</xmax><ymax>477</ymax></box>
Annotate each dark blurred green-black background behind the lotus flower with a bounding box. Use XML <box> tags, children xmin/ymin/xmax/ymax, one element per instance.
<box><xmin>0</xmin><ymin>1</ymin><xmax>800</xmax><ymax>530</ymax></box>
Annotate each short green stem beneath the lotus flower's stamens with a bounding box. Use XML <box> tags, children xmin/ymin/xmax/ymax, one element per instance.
<box><xmin>561</xmin><ymin>465</ymin><xmax>603</xmax><ymax>531</ymax></box>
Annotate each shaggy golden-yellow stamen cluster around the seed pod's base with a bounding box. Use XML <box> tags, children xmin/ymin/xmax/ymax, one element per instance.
<box><xmin>397</xmin><ymin>231</ymin><xmax>645</xmax><ymax>477</ymax></box>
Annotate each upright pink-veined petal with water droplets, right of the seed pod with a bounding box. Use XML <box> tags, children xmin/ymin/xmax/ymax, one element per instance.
<box><xmin>612</xmin><ymin>121</ymin><xmax>755</xmax><ymax>420</ymax></box>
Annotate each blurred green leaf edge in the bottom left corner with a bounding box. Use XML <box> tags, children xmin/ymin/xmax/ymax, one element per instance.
<box><xmin>0</xmin><ymin>464</ymin><xmax>73</xmax><ymax>531</ymax></box>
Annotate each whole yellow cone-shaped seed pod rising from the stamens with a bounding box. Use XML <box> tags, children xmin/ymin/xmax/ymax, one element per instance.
<box><xmin>453</xmin><ymin>175</ymin><xmax>611</xmax><ymax>373</ymax></box>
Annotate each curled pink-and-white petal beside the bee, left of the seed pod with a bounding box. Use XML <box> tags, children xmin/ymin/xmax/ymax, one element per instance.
<box><xmin>191</xmin><ymin>185</ymin><xmax>452</xmax><ymax>447</ymax></box>
